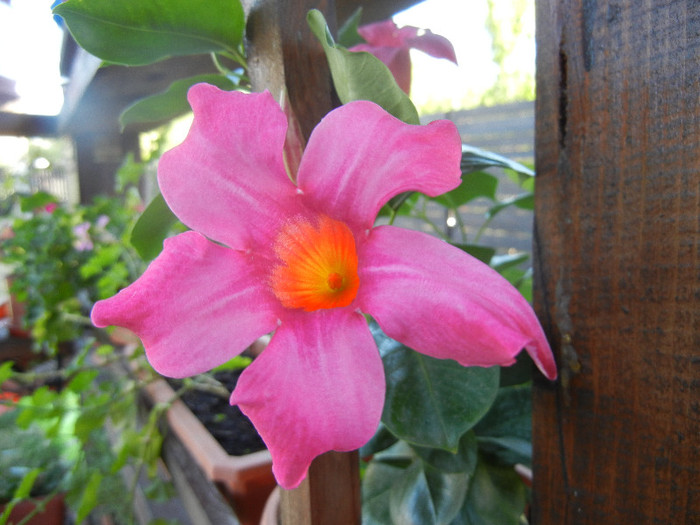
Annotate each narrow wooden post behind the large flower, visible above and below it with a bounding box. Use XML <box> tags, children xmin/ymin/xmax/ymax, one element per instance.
<box><xmin>247</xmin><ymin>0</ymin><xmax>361</xmax><ymax>525</ymax></box>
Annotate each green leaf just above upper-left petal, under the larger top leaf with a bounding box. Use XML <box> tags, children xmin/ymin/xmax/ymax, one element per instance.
<box><xmin>119</xmin><ymin>74</ymin><xmax>236</xmax><ymax>130</ymax></box>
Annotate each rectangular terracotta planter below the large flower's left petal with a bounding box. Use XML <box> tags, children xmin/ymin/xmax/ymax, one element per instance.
<box><xmin>145</xmin><ymin>380</ymin><xmax>276</xmax><ymax>525</ymax></box>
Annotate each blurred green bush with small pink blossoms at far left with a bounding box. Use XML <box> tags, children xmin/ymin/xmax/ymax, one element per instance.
<box><xmin>3</xmin><ymin>192</ymin><xmax>143</xmax><ymax>353</ymax></box>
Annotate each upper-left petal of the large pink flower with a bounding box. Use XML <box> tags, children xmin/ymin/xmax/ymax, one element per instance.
<box><xmin>158</xmin><ymin>84</ymin><xmax>295</xmax><ymax>249</ymax></box>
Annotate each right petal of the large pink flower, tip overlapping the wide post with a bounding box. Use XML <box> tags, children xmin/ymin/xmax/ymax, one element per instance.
<box><xmin>356</xmin><ymin>226</ymin><xmax>557</xmax><ymax>379</ymax></box>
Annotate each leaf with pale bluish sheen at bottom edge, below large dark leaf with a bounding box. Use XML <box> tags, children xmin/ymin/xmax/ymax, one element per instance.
<box><xmin>389</xmin><ymin>462</ymin><xmax>469</xmax><ymax>525</ymax></box>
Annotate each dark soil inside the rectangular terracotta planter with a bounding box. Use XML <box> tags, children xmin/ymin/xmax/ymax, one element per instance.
<box><xmin>171</xmin><ymin>370</ymin><xmax>265</xmax><ymax>456</ymax></box>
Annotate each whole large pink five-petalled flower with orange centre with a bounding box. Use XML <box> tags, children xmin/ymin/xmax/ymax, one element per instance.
<box><xmin>92</xmin><ymin>84</ymin><xmax>556</xmax><ymax>488</ymax></box>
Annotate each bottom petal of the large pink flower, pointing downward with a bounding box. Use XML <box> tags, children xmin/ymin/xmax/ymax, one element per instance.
<box><xmin>231</xmin><ymin>308</ymin><xmax>385</xmax><ymax>489</ymax></box>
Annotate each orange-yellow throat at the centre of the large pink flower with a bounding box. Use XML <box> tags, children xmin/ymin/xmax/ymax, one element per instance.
<box><xmin>270</xmin><ymin>215</ymin><xmax>360</xmax><ymax>312</ymax></box>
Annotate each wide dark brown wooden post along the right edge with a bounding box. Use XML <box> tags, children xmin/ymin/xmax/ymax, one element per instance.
<box><xmin>532</xmin><ymin>0</ymin><xmax>700</xmax><ymax>525</ymax></box>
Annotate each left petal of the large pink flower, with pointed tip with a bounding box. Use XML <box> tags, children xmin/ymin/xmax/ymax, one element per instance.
<box><xmin>92</xmin><ymin>232</ymin><xmax>281</xmax><ymax>377</ymax></box>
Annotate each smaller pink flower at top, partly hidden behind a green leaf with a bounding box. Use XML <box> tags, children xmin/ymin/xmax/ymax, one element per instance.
<box><xmin>350</xmin><ymin>20</ymin><xmax>457</xmax><ymax>93</ymax></box>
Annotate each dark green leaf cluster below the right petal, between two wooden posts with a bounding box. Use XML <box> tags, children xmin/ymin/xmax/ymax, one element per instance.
<box><xmin>360</xmin><ymin>323</ymin><xmax>531</xmax><ymax>525</ymax></box>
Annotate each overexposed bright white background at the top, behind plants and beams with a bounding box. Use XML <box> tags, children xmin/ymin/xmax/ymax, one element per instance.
<box><xmin>0</xmin><ymin>0</ymin><xmax>535</xmax><ymax>186</ymax></box>
